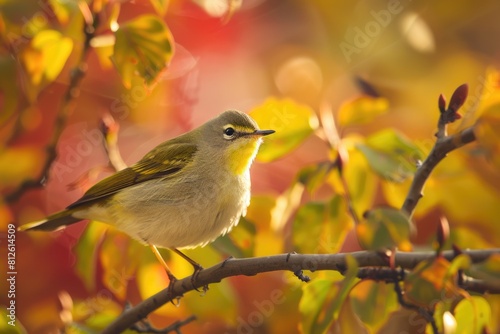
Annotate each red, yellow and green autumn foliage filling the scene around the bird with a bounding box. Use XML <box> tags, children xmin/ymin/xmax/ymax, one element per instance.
<box><xmin>0</xmin><ymin>0</ymin><xmax>500</xmax><ymax>333</ymax></box>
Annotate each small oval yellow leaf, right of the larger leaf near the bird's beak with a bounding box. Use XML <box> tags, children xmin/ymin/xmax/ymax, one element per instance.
<box><xmin>338</xmin><ymin>96</ymin><xmax>389</xmax><ymax>127</ymax></box>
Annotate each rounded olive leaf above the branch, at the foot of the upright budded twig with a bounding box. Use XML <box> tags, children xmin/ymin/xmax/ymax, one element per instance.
<box><xmin>356</xmin><ymin>208</ymin><xmax>412</xmax><ymax>250</ymax></box>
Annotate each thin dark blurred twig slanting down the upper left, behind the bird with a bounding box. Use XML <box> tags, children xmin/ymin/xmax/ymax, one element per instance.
<box><xmin>4</xmin><ymin>12</ymin><xmax>98</xmax><ymax>203</ymax></box>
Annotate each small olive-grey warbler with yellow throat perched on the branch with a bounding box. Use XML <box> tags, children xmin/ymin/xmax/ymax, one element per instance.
<box><xmin>19</xmin><ymin>110</ymin><xmax>274</xmax><ymax>283</ymax></box>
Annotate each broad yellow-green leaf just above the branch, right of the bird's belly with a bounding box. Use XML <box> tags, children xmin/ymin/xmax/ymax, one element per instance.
<box><xmin>293</xmin><ymin>195</ymin><xmax>353</xmax><ymax>253</ymax></box>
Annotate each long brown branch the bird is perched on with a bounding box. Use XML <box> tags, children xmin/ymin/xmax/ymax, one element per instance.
<box><xmin>102</xmin><ymin>249</ymin><xmax>500</xmax><ymax>334</ymax></box>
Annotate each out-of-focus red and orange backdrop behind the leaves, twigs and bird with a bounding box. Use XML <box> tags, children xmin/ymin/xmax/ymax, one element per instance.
<box><xmin>0</xmin><ymin>0</ymin><xmax>500</xmax><ymax>333</ymax></box>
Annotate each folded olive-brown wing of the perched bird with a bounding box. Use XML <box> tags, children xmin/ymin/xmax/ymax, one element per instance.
<box><xmin>68</xmin><ymin>141</ymin><xmax>197</xmax><ymax>209</ymax></box>
